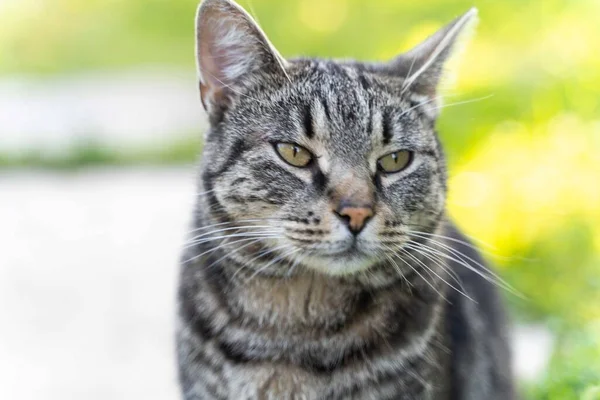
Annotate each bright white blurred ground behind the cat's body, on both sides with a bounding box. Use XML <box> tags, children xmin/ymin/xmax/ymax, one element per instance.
<box><xmin>0</xmin><ymin>167</ymin><xmax>551</xmax><ymax>400</ymax></box>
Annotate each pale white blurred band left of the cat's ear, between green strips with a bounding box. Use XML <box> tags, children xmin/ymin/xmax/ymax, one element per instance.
<box><xmin>0</xmin><ymin>69</ymin><xmax>205</xmax><ymax>155</ymax></box>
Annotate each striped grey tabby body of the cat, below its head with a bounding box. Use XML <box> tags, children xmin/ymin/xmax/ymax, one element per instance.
<box><xmin>179</xmin><ymin>220</ymin><xmax>513</xmax><ymax>400</ymax></box>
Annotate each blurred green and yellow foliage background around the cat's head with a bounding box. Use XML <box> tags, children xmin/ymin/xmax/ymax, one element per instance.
<box><xmin>0</xmin><ymin>0</ymin><xmax>600</xmax><ymax>400</ymax></box>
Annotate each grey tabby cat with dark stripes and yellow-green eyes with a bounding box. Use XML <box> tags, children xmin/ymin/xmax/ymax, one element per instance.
<box><xmin>177</xmin><ymin>0</ymin><xmax>515</xmax><ymax>400</ymax></box>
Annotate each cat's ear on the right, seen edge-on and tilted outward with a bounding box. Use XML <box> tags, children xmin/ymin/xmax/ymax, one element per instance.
<box><xmin>388</xmin><ymin>8</ymin><xmax>477</xmax><ymax>98</ymax></box>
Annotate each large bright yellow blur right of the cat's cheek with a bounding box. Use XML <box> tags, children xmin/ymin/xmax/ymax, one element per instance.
<box><xmin>448</xmin><ymin>114</ymin><xmax>600</xmax><ymax>253</ymax></box>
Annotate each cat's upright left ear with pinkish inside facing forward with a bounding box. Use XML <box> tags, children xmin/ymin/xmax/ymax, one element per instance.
<box><xmin>196</xmin><ymin>0</ymin><xmax>286</xmax><ymax>113</ymax></box>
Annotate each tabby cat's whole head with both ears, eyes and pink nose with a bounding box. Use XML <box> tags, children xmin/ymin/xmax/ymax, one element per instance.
<box><xmin>197</xmin><ymin>0</ymin><xmax>476</xmax><ymax>275</ymax></box>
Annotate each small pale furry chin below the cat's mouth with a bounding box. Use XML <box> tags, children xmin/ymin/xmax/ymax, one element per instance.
<box><xmin>303</xmin><ymin>252</ymin><xmax>377</xmax><ymax>276</ymax></box>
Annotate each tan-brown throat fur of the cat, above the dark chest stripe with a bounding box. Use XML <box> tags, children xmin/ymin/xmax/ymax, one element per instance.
<box><xmin>213</xmin><ymin>265</ymin><xmax>439</xmax><ymax>336</ymax></box>
